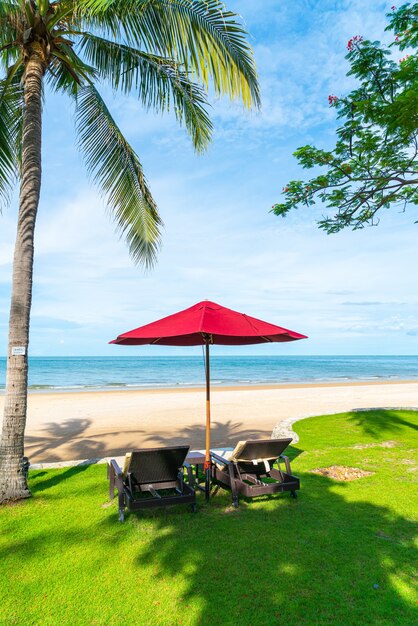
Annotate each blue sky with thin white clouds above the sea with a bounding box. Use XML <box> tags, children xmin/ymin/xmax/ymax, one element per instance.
<box><xmin>0</xmin><ymin>0</ymin><xmax>418</xmax><ymax>355</ymax></box>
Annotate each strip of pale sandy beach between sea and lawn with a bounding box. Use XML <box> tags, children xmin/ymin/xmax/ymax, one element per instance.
<box><xmin>0</xmin><ymin>381</ymin><xmax>418</xmax><ymax>463</ymax></box>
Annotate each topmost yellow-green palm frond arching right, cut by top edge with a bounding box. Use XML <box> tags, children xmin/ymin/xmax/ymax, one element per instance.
<box><xmin>86</xmin><ymin>0</ymin><xmax>260</xmax><ymax>107</ymax></box>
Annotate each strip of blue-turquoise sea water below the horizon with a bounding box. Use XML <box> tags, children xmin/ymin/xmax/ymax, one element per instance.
<box><xmin>0</xmin><ymin>355</ymin><xmax>418</xmax><ymax>392</ymax></box>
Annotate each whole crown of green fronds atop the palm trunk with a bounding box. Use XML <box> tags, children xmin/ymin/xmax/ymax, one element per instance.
<box><xmin>0</xmin><ymin>0</ymin><xmax>259</xmax><ymax>265</ymax></box>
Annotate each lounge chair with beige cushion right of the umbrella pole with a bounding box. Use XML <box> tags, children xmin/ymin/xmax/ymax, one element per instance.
<box><xmin>211</xmin><ymin>438</ymin><xmax>300</xmax><ymax>507</ymax></box>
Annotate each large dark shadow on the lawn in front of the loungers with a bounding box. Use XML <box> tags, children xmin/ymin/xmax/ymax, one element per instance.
<box><xmin>122</xmin><ymin>475</ymin><xmax>418</xmax><ymax>625</ymax></box>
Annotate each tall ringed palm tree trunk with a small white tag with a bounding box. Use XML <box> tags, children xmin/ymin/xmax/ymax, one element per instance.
<box><xmin>0</xmin><ymin>53</ymin><xmax>44</xmax><ymax>502</ymax></box>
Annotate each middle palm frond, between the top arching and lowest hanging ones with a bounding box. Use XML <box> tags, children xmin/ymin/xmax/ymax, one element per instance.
<box><xmin>81</xmin><ymin>33</ymin><xmax>213</xmax><ymax>151</ymax></box>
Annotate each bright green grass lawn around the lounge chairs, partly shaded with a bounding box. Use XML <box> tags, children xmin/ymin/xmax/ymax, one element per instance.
<box><xmin>0</xmin><ymin>410</ymin><xmax>418</xmax><ymax>626</ymax></box>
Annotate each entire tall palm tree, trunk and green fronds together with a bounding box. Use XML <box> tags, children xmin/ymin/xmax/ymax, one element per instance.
<box><xmin>0</xmin><ymin>0</ymin><xmax>259</xmax><ymax>502</ymax></box>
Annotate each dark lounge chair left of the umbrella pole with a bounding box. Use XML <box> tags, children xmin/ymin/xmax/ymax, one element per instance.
<box><xmin>107</xmin><ymin>446</ymin><xmax>196</xmax><ymax>522</ymax></box>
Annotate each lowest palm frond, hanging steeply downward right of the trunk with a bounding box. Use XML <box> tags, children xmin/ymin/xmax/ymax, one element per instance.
<box><xmin>76</xmin><ymin>84</ymin><xmax>162</xmax><ymax>266</ymax></box>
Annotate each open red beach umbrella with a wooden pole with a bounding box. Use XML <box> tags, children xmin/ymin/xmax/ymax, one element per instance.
<box><xmin>110</xmin><ymin>300</ymin><xmax>307</xmax><ymax>497</ymax></box>
